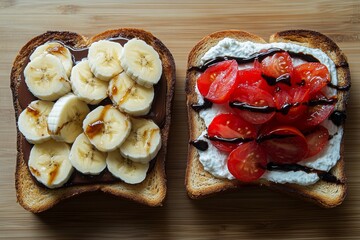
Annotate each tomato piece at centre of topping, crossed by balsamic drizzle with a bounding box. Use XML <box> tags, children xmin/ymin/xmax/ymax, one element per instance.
<box><xmin>274</xmin><ymin>85</ymin><xmax>309</xmax><ymax>123</ymax></box>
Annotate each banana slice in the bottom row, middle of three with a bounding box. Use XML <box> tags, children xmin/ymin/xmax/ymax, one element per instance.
<box><xmin>70</xmin><ymin>133</ymin><xmax>106</xmax><ymax>175</ymax></box>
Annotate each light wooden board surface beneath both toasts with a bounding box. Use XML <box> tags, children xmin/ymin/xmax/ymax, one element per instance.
<box><xmin>0</xmin><ymin>0</ymin><xmax>360</xmax><ymax>239</ymax></box>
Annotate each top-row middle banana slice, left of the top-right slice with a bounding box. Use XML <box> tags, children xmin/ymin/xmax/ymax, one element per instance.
<box><xmin>88</xmin><ymin>40</ymin><xmax>123</xmax><ymax>81</ymax></box>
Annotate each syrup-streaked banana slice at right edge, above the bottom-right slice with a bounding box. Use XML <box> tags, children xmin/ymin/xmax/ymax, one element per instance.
<box><xmin>120</xmin><ymin>118</ymin><xmax>161</xmax><ymax>163</ymax></box>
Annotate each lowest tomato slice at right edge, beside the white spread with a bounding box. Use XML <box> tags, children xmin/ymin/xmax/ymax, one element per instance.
<box><xmin>305</xmin><ymin>125</ymin><xmax>329</xmax><ymax>158</ymax></box>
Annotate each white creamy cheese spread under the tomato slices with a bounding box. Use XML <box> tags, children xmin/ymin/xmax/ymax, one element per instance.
<box><xmin>195</xmin><ymin>38</ymin><xmax>343</xmax><ymax>185</ymax></box>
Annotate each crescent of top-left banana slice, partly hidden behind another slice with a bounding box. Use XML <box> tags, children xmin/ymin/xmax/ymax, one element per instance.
<box><xmin>30</xmin><ymin>42</ymin><xmax>73</xmax><ymax>77</ymax></box>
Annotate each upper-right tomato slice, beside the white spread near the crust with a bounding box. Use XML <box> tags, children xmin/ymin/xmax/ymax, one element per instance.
<box><xmin>292</xmin><ymin>62</ymin><xmax>330</xmax><ymax>95</ymax></box>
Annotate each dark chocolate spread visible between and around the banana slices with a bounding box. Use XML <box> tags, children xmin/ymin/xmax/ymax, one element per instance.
<box><xmin>18</xmin><ymin>37</ymin><xmax>167</xmax><ymax>187</ymax></box>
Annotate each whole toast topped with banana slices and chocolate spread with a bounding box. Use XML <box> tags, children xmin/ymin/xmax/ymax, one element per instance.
<box><xmin>10</xmin><ymin>28</ymin><xmax>175</xmax><ymax>213</ymax></box>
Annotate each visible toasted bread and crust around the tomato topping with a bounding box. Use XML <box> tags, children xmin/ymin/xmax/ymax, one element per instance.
<box><xmin>185</xmin><ymin>30</ymin><xmax>350</xmax><ymax>208</ymax></box>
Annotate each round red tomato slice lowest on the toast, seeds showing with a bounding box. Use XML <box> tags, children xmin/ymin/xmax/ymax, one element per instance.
<box><xmin>227</xmin><ymin>142</ymin><xmax>267</xmax><ymax>182</ymax></box>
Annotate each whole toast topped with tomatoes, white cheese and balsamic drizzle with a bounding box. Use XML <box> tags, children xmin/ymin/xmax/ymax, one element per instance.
<box><xmin>185</xmin><ymin>30</ymin><xmax>350</xmax><ymax>208</ymax></box>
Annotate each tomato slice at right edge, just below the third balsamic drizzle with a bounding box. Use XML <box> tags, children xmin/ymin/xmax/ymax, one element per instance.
<box><xmin>297</xmin><ymin>93</ymin><xmax>335</xmax><ymax>130</ymax></box>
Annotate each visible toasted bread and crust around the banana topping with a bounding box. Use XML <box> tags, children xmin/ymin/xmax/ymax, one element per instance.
<box><xmin>10</xmin><ymin>28</ymin><xmax>175</xmax><ymax>213</ymax></box>
